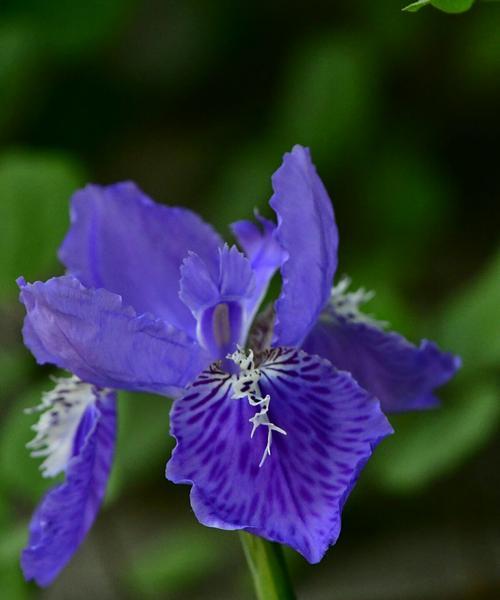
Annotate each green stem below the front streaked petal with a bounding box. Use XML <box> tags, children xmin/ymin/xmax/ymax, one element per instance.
<box><xmin>240</xmin><ymin>531</ymin><xmax>295</xmax><ymax>600</ymax></box>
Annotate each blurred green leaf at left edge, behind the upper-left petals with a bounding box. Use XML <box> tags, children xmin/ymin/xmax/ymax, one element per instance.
<box><xmin>0</xmin><ymin>152</ymin><xmax>83</xmax><ymax>301</ymax></box>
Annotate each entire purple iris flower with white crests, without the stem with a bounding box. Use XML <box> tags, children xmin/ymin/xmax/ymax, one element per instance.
<box><xmin>19</xmin><ymin>146</ymin><xmax>459</xmax><ymax>585</ymax></box>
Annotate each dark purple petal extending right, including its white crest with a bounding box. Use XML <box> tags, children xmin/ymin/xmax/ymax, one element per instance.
<box><xmin>303</xmin><ymin>280</ymin><xmax>461</xmax><ymax>412</ymax></box>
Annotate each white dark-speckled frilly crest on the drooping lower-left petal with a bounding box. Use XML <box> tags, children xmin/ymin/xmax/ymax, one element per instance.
<box><xmin>25</xmin><ymin>376</ymin><xmax>96</xmax><ymax>477</ymax></box>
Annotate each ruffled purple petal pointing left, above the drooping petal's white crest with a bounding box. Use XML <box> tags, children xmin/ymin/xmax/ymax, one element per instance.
<box><xmin>19</xmin><ymin>276</ymin><xmax>209</xmax><ymax>394</ymax></box>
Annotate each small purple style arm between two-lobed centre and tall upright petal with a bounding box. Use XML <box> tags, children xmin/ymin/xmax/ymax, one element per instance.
<box><xmin>231</xmin><ymin>214</ymin><xmax>286</xmax><ymax>322</ymax></box>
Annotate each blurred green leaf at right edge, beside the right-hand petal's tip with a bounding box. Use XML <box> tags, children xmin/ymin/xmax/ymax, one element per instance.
<box><xmin>440</xmin><ymin>249</ymin><xmax>500</xmax><ymax>371</ymax></box>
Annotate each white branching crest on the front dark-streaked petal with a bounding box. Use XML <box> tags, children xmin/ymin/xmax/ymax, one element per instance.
<box><xmin>226</xmin><ymin>346</ymin><xmax>286</xmax><ymax>467</ymax></box>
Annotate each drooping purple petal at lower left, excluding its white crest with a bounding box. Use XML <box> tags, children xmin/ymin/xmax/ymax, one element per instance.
<box><xmin>21</xmin><ymin>382</ymin><xmax>116</xmax><ymax>586</ymax></box>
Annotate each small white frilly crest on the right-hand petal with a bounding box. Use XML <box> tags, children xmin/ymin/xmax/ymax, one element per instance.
<box><xmin>321</xmin><ymin>276</ymin><xmax>388</xmax><ymax>329</ymax></box>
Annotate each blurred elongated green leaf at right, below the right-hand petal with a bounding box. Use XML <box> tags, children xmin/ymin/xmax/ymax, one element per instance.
<box><xmin>368</xmin><ymin>380</ymin><xmax>500</xmax><ymax>493</ymax></box>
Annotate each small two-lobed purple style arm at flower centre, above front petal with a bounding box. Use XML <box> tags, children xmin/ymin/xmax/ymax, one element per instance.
<box><xmin>179</xmin><ymin>245</ymin><xmax>255</xmax><ymax>359</ymax></box>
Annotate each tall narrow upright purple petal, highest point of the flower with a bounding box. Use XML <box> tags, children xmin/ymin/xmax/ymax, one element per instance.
<box><xmin>270</xmin><ymin>146</ymin><xmax>338</xmax><ymax>346</ymax></box>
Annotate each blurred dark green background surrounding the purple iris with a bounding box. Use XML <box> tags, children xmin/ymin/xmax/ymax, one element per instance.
<box><xmin>0</xmin><ymin>0</ymin><xmax>500</xmax><ymax>600</ymax></box>
